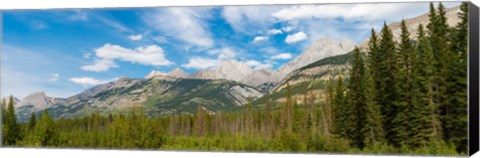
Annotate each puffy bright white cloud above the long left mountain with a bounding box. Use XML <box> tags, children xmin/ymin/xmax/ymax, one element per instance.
<box><xmin>82</xmin><ymin>43</ymin><xmax>173</xmax><ymax>72</ymax></box>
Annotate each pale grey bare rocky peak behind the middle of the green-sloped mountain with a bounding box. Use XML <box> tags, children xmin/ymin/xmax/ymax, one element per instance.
<box><xmin>190</xmin><ymin>60</ymin><xmax>254</xmax><ymax>82</ymax></box>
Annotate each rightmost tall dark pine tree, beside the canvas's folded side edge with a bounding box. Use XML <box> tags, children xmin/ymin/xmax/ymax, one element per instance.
<box><xmin>439</xmin><ymin>2</ymin><xmax>468</xmax><ymax>152</ymax></box>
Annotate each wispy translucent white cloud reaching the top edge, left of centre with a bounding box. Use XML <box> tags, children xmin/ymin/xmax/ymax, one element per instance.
<box><xmin>143</xmin><ymin>7</ymin><xmax>214</xmax><ymax>48</ymax></box>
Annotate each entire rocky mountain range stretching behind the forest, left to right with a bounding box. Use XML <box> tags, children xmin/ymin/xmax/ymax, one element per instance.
<box><xmin>5</xmin><ymin>4</ymin><xmax>459</xmax><ymax>121</ymax></box>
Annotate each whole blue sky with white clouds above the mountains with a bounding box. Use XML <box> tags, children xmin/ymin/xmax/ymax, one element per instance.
<box><xmin>0</xmin><ymin>2</ymin><xmax>459</xmax><ymax>99</ymax></box>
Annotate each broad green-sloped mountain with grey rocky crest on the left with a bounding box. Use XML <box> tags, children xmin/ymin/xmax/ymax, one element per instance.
<box><xmin>17</xmin><ymin>76</ymin><xmax>263</xmax><ymax>121</ymax></box>
